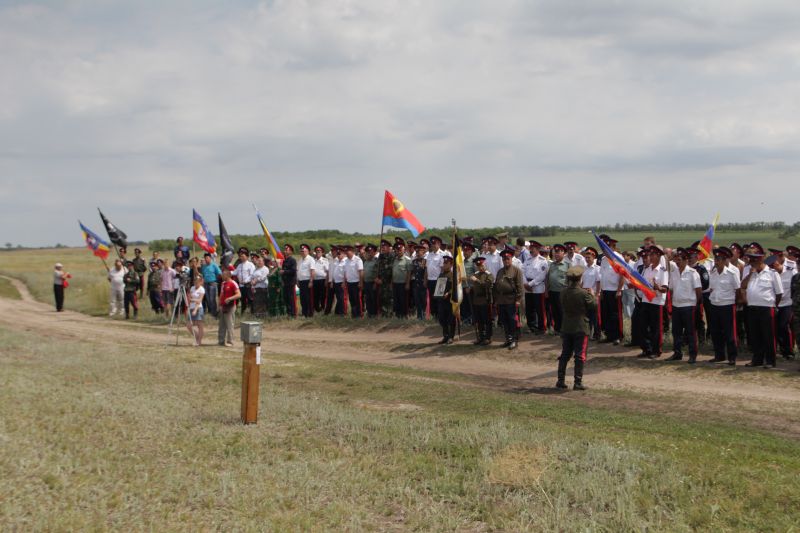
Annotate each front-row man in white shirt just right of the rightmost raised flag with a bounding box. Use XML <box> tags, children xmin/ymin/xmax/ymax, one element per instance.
<box><xmin>708</xmin><ymin>248</ymin><xmax>741</xmax><ymax>366</ymax></box>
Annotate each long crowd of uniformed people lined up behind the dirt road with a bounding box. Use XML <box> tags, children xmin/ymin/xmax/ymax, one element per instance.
<box><xmin>51</xmin><ymin>229</ymin><xmax>800</xmax><ymax>385</ymax></box>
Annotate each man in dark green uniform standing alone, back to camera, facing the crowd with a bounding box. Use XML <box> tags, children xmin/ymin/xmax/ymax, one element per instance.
<box><xmin>556</xmin><ymin>266</ymin><xmax>597</xmax><ymax>390</ymax></box>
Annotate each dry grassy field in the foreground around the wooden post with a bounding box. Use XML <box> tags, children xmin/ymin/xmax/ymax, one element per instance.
<box><xmin>0</xmin><ymin>328</ymin><xmax>800</xmax><ymax>531</ymax></box>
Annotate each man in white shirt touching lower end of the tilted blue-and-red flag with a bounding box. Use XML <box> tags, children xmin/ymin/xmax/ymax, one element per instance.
<box><xmin>640</xmin><ymin>246</ymin><xmax>669</xmax><ymax>359</ymax></box>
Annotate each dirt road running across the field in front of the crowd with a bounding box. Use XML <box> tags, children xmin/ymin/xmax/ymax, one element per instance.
<box><xmin>0</xmin><ymin>278</ymin><xmax>800</xmax><ymax>435</ymax></box>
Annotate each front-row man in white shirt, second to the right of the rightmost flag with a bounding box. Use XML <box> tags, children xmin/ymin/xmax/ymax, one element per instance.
<box><xmin>742</xmin><ymin>242</ymin><xmax>783</xmax><ymax>368</ymax></box>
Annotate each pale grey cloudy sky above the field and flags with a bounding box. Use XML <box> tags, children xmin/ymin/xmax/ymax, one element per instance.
<box><xmin>0</xmin><ymin>0</ymin><xmax>800</xmax><ymax>246</ymax></box>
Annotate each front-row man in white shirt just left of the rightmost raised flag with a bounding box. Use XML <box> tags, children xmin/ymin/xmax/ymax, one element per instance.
<box><xmin>667</xmin><ymin>248</ymin><xmax>703</xmax><ymax>365</ymax></box>
